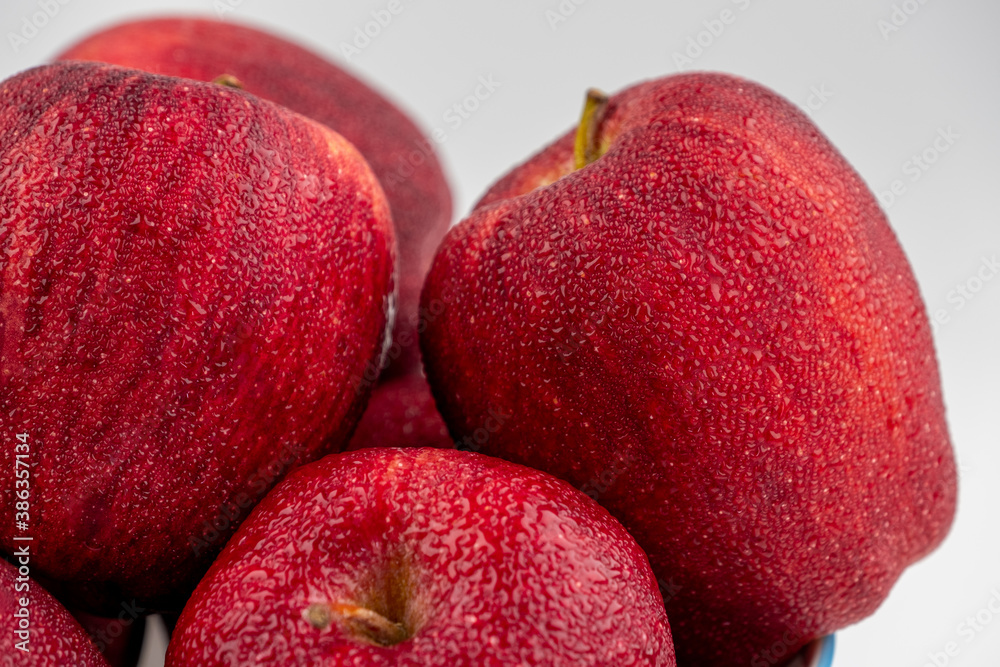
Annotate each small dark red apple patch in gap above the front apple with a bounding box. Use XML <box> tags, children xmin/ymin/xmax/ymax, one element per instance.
<box><xmin>345</xmin><ymin>373</ymin><xmax>455</xmax><ymax>452</ymax></box>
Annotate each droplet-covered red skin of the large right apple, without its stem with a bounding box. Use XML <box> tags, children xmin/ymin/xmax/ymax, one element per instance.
<box><xmin>421</xmin><ymin>73</ymin><xmax>956</xmax><ymax>667</ymax></box>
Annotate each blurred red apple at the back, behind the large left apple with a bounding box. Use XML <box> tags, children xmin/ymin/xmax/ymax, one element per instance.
<box><xmin>58</xmin><ymin>18</ymin><xmax>452</xmax><ymax>377</ymax></box>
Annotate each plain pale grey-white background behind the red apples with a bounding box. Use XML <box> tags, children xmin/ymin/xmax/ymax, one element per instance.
<box><xmin>0</xmin><ymin>0</ymin><xmax>1000</xmax><ymax>667</ymax></box>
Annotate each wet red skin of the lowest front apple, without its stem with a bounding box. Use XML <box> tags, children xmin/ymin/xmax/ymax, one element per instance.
<box><xmin>167</xmin><ymin>449</ymin><xmax>675</xmax><ymax>667</ymax></box>
